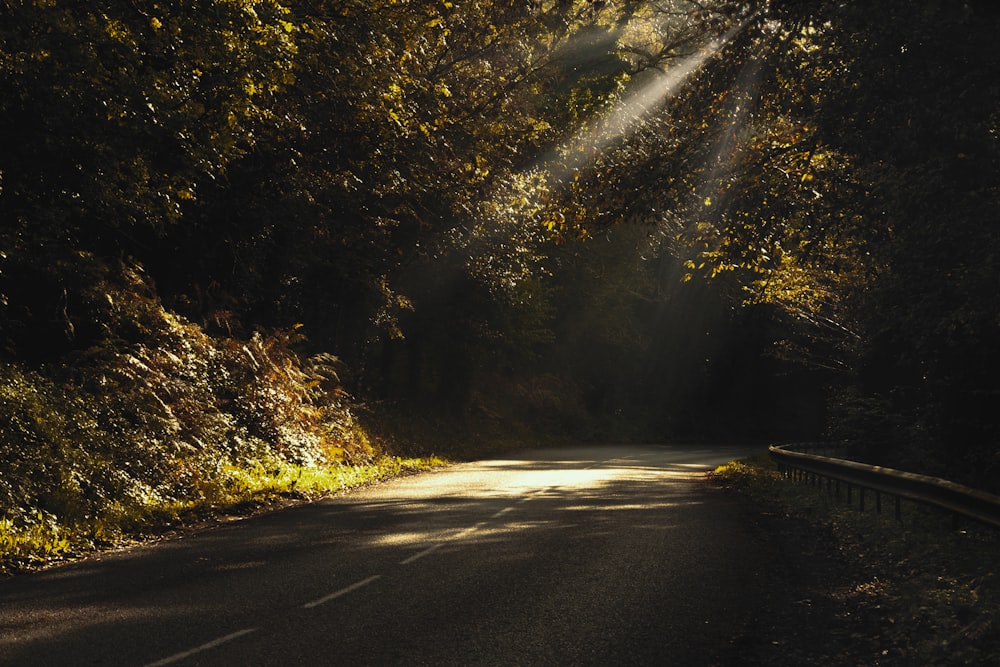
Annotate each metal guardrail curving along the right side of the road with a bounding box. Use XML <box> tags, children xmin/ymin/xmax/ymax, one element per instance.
<box><xmin>768</xmin><ymin>444</ymin><xmax>1000</xmax><ymax>528</ymax></box>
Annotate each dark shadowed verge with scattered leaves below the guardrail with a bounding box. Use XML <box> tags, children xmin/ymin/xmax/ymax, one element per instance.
<box><xmin>713</xmin><ymin>457</ymin><xmax>1000</xmax><ymax>665</ymax></box>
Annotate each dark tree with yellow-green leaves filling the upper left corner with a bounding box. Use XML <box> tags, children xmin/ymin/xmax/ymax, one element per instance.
<box><xmin>0</xmin><ymin>0</ymin><xmax>294</xmax><ymax>355</ymax></box>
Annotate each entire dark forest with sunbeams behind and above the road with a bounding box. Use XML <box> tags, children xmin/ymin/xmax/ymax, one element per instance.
<box><xmin>0</xmin><ymin>0</ymin><xmax>1000</xmax><ymax>560</ymax></box>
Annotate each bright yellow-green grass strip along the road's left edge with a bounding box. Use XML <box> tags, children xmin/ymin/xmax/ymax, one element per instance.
<box><xmin>0</xmin><ymin>456</ymin><xmax>447</xmax><ymax>575</ymax></box>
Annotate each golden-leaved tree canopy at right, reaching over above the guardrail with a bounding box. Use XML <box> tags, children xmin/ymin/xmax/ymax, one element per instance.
<box><xmin>552</xmin><ymin>1</ymin><xmax>1000</xmax><ymax>484</ymax></box>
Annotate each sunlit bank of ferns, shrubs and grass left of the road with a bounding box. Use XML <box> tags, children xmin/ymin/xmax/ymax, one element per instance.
<box><xmin>0</xmin><ymin>265</ymin><xmax>448</xmax><ymax>570</ymax></box>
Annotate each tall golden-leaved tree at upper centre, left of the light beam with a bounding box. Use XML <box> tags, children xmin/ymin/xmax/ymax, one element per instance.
<box><xmin>153</xmin><ymin>2</ymin><xmax>644</xmax><ymax>408</ymax></box>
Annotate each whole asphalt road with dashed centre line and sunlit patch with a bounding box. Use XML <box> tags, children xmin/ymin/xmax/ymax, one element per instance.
<box><xmin>0</xmin><ymin>445</ymin><xmax>767</xmax><ymax>667</ymax></box>
